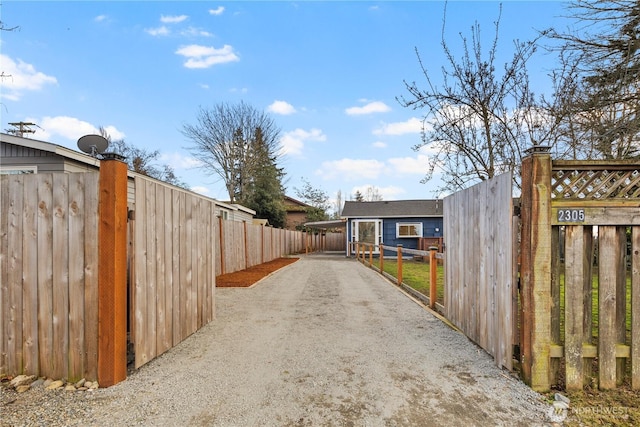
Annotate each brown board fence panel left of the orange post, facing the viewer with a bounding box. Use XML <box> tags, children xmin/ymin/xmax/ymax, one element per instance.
<box><xmin>0</xmin><ymin>173</ymin><xmax>99</xmax><ymax>380</ymax></box>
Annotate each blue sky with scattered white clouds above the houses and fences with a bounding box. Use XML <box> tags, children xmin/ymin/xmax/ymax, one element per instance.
<box><xmin>0</xmin><ymin>0</ymin><xmax>566</xmax><ymax>209</ymax></box>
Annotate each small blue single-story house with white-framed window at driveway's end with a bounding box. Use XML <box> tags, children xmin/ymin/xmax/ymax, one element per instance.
<box><xmin>341</xmin><ymin>199</ymin><xmax>444</xmax><ymax>255</ymax></box>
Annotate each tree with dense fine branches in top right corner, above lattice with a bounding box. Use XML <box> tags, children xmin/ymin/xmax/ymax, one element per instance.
<box><xmin>551</xmin><ymin>0</ymin><xmax>640</xmax><ymax>159</ymax></box>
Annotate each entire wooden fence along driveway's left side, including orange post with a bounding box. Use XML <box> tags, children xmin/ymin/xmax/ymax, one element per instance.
<box><xmin>0</xmin><ymin>166</ymin><xmax>318</xmax><ymax>386</ymax></box>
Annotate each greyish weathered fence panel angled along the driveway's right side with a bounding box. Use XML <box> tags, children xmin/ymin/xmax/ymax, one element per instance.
<box><xmin>444</xmin><ymin>173</ymin><xmax>513</xmax><ymax>369</ymax></box>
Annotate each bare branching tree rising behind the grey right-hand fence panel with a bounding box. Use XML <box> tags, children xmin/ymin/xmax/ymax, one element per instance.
<box><xmin>398</xmin><ymin>3</ymin><xmax>553</xmax><ymax>191</ymax></box>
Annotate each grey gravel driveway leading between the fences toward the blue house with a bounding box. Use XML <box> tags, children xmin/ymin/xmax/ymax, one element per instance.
<box><xmin>0</xmin><ymin>255</ymin><xmax>549</xmax><ymax>426</ymax></box>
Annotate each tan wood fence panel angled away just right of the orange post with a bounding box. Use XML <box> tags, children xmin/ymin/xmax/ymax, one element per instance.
<box><xmin>131</xmin><ymin>177</ymin><xmax>216</xmax><ymax>368</ymax></box>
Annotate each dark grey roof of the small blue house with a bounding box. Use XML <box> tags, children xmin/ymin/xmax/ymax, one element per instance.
<box><xmin>342</xmin><ymin>199</ymin><xmax>443</xmax><ymax>218</ymax></box>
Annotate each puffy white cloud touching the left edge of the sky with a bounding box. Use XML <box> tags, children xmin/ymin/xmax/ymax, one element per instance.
<box><xmin>0</xmin><ymin>54</ymin><xmax>58</xmax><ymax>101</ymax></box>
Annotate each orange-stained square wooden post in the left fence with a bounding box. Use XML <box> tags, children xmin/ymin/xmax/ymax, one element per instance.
<box><xmin>98</xmin><ymin>153</ymin><xmax>127</xmax><ymax>387</ymax></box>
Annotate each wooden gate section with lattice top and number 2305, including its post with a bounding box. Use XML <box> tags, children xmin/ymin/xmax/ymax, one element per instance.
<box><xmin>521</xmin><ymin>150</ymin><xmax>640</xmax><ymax>391</ymax></box>
